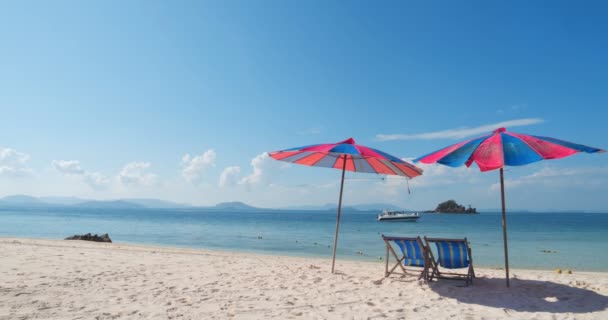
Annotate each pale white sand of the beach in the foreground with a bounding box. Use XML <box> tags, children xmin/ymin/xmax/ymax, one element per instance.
<box><xmin>0</xmin><ymin>238</ymin><xmax>608</xmax><ymax>320</ymax></box>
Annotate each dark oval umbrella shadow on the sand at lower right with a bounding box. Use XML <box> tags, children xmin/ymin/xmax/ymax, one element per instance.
<box><xmin>429</xmin><ymin>277</ymin><xmax>608</xmax><ymax>313</ymax></box>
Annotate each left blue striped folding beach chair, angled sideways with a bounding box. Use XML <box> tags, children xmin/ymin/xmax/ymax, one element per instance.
<box><xmin>382</xmin><ymin>235</ymin><xmax>428</xmax><ymax>281</ymax></box>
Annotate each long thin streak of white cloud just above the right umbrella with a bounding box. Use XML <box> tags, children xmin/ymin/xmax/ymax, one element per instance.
<box><xmin>376</xmin><ymin>118</ymin><xmax>544</xmax><ymax>141</ymax></box>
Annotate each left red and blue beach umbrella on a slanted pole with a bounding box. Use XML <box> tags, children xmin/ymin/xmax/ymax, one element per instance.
<box><xmin>269</xmin><ymin>138</ymin><xmax>422</xmax><ymax>273</ymax></box>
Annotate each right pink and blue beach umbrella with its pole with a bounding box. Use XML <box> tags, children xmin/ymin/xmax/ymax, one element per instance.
<box><xmin>414</xmin><ymin>128</ymin><xmax>604</xmax><ymax>287</ymax></box>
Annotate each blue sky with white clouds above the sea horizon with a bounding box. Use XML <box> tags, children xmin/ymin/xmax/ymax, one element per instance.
<box><xmin>0</xmin><ymin>1</ymin><xmax>608</xmax><ymax>210</ymax></box>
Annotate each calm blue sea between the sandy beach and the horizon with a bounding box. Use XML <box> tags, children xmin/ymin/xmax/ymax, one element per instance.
<box><xmin>0</xmin><ymin>208</ymin><xmax>608</xmax><ymax>271</ymax></box>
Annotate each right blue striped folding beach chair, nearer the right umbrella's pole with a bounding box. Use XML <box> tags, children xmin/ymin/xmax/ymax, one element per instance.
<box><xmin>424</xmin><ymin>237</ymin><xmax>475</xmax><ymax>286</ymax></box>
